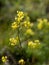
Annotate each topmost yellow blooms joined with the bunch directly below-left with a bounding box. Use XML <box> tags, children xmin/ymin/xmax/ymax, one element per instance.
<box><xmin>11</xmin><ymin>11</ymin><xmax>24</xmax><ymax>29</ymax></box>
